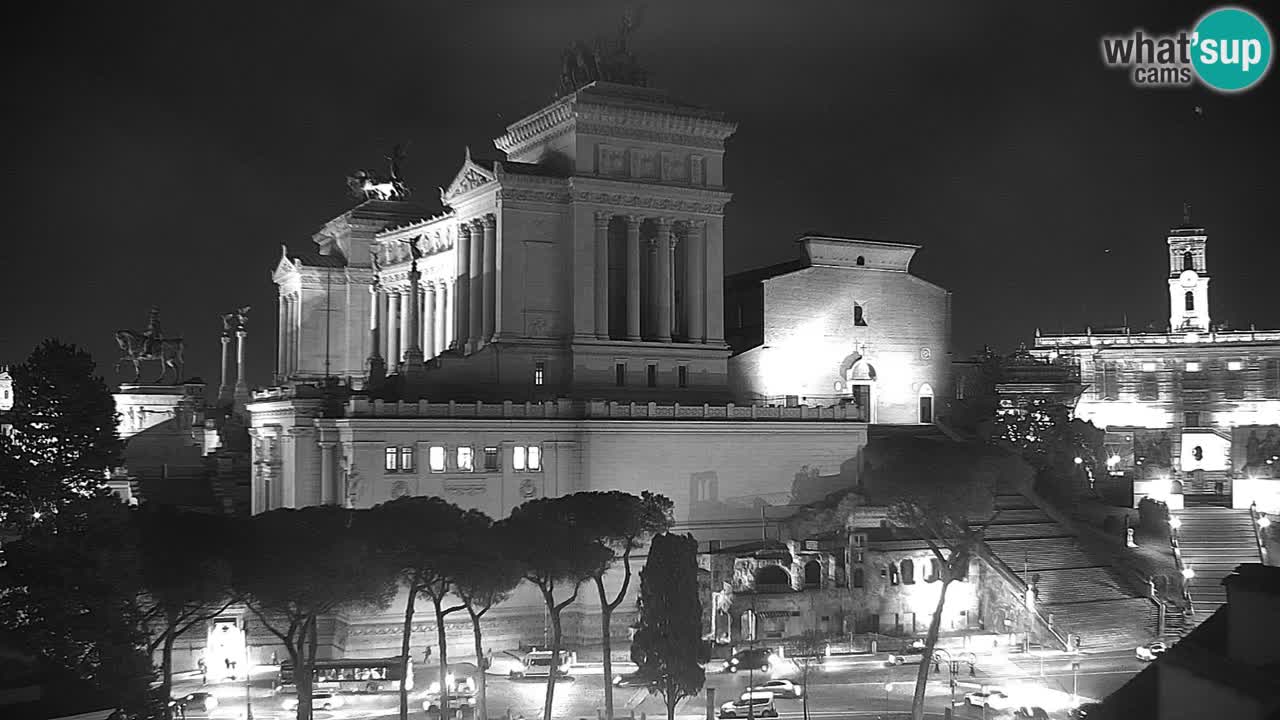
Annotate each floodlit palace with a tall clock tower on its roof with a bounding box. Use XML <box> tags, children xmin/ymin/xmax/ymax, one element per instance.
<box><xmin>1033</xmin><ymin>220</ymin><xmax>1280</xmax><ymax>512</ymax></box>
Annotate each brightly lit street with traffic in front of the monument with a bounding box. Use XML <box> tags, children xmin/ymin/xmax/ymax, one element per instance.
<box><xmin>174</xmin><ymin>648</ymin><xmax>1143</xmax><ymax>720</ymax></box>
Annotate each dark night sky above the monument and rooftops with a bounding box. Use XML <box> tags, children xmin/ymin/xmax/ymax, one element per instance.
<box><xmin>0</xmin><ymin>0</ymin><xmax>1280</xmax><ymax>386</ymax></box>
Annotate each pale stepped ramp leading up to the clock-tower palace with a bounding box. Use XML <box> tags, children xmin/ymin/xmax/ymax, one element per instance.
<box><xmin>1172</xmin><ymin>506</ymin><xmax>1262</xmax><ymax>624</ymax></box>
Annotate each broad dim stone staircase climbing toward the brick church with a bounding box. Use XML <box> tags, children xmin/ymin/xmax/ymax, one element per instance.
<box><xmin>986</xmin><ymin>493</ymin><xmax>1157</xmax><ymax>650</ymax></box>
